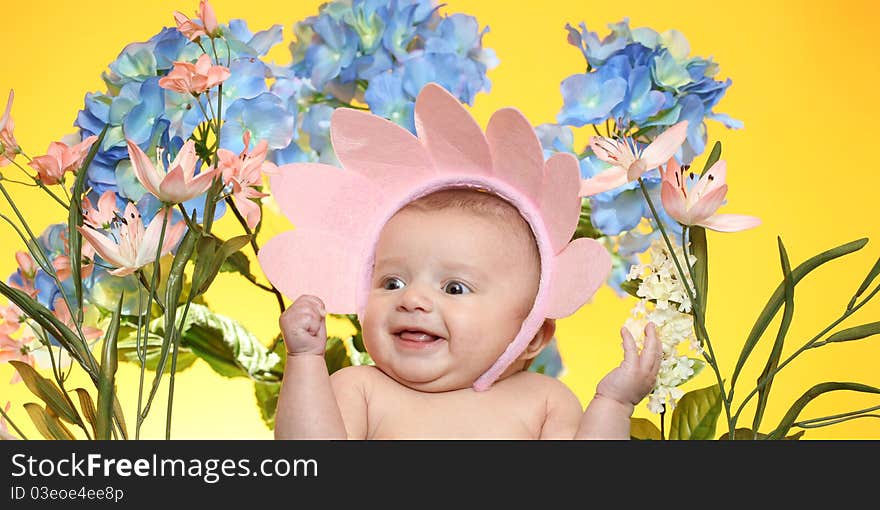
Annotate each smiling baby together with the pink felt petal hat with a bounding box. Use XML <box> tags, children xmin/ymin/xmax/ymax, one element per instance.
<box><xmin>259</xmin><ymin>84</ymin><xmax>661</xmax><ymax>439</ymax></box>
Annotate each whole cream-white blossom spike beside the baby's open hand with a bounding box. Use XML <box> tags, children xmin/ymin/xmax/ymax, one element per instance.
<box><xmin>624</xmin><ymin>239</ymin><xmax>702</xmax><ymax>413</ymax></box>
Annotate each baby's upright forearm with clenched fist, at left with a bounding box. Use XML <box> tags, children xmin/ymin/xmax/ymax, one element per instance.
<box><xmin>275</xmin><ymin>296</ymin><xmax>347</xmax><ymax>439</ymax></box>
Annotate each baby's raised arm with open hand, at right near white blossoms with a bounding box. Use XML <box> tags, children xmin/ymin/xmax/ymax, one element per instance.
<box><xmin>575</xmin><ymin>323</ymin><xmax>663</xmax><ymax>439</ymax></box>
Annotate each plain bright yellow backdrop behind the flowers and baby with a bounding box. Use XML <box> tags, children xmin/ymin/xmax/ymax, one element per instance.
<box><xmin>0</xmin><ymin>0</ymin><xmax>880</xmax><ymax>439</ymax></box>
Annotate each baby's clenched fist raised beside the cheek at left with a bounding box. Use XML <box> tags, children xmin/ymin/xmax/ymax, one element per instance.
<box><xmin>278</xmin><ymin>295</ymin><xmax>327</xmax><ymax>356</ymax></box>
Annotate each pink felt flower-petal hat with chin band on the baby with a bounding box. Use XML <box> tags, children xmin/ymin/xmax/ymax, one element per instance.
<box><xmin>258</xmin><ymin>83</ymin><xmax>611</xmax><ymax>391</ymax></box>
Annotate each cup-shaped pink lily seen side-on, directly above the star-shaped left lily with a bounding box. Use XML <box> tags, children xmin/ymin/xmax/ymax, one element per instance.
<box><xmin>127</xmin><ymin>140</ymin><xmax>218</xmax><ymax>205</ymax></box>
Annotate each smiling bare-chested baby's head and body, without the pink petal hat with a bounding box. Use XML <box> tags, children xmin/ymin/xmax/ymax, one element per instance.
<box><xmin>275</xmin><ymin>190</ymin><xmax>660</xmax><ymax>439</ymax></box>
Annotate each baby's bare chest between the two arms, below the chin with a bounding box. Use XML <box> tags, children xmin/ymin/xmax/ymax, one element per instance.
<box><xmin>367</xmin><ymin>386</ymin><xmax>546</xmax><ymax>439</ymax></box>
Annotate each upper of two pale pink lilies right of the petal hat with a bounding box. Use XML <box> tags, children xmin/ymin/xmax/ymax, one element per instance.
<box><xmin>579</xmin><ymin>120</ymin><xmax>688</xmax><ymax>197</ymax></box>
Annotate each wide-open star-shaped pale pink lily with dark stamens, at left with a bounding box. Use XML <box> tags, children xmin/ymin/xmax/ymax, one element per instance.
<box><xmin>77</xmin><ymin>202</ymin><xmax>186</xmax><ymax>276</ymax></box>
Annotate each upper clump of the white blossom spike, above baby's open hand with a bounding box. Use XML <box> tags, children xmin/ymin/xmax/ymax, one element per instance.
<box><xmin>627</xmin><ymin>238</ymin><xmax>697</xmax><ymax>312</ymax></box>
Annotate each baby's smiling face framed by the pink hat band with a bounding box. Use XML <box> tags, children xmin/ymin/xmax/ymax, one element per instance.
<box><xmin>363</xmin><ymin>205</ymin><xmax>540</xmax><ymax>392</ymax></box>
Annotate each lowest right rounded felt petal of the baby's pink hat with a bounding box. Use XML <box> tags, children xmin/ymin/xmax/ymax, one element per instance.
<box><xmin>535</xmin><ymin>237</ymin><xmax>611</xmax><ymax>319</ymax></box>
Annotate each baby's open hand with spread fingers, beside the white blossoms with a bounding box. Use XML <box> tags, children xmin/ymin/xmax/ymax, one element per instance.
<box><xmin>596</xmin><ymin>322</ymin><xmax>663</xmax><ymax>405</ymax></box>
